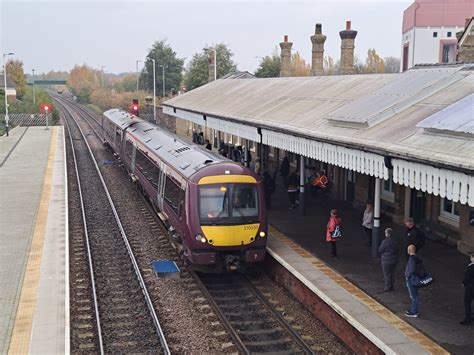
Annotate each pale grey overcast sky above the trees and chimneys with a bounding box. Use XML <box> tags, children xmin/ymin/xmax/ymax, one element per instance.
<box><xmin>0</xmin><ymin>0</ymin><xmax>413</xmax><ymax>73</ymax></box>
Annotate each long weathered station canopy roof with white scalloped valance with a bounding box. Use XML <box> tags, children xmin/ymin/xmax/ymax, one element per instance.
<box><xmin>163</xmin><ymin>65</ymin><xmax>474</xmax><ymax>206</ymax></box>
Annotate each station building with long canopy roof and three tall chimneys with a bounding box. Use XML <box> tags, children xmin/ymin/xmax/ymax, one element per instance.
<box><xmin>163</xmin><ymin>23</ymin><xmax>474</xmax><ymax>253</ymax></box>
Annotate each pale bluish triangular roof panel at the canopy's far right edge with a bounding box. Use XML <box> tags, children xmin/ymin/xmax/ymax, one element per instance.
<box><xmin>417</xmin><ymin>93</ymin><xmax>474</xmax><ymax>134</ymax></box>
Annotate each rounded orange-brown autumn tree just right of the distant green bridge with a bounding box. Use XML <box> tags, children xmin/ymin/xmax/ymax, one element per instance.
<box><xmin>67</xmin><ymin>64</ymin><xmax>99</xmax><ymax>103</ymax></box>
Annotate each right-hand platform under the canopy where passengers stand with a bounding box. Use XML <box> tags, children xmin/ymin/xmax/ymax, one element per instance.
<box><xmin>268</xmin><ymin>182</ymin><xmax>474</xmax><ymax>354</ymax></box>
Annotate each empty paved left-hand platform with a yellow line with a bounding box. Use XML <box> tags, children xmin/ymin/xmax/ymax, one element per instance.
<box><xmin>0</xmin><ymin>127</ymin><xmax>69</xmax><ymax>354</ymax></box>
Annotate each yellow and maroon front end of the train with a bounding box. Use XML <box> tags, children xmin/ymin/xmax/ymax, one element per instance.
<box><xmin>187</xmin><ymin>163</ymin><xmax>268</xmax><ymax>271</ymax></box>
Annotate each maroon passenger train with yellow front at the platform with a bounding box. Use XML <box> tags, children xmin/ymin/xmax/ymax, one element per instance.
<box><xmin>102</xmin><ymin>109</ymin><xmax>268</xmax><ymax>272</ymax></box>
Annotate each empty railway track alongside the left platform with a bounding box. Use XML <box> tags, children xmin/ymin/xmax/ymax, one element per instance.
<box><xmin>61</xmin><ymin>101</ymin><xmax>169</xmax><ymax>354</ymax></box>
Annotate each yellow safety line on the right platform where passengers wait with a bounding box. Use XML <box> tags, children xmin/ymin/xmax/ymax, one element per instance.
<box><xmin>269</xmin><ymin>226</ymin><xmax>449</xmax><ymax>354</ymax></box>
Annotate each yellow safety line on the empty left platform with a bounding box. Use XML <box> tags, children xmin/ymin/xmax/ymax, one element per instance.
<box><xmin>8</xmin><ymin>127</ymin><xmax>59</xmax><ymax>354</ymax></box>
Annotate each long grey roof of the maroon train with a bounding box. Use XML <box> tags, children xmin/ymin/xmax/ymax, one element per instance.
<box><xmin>104</xmin><ymin>109</ymin><xmax>229</xmax><ymax>178</ymax></box>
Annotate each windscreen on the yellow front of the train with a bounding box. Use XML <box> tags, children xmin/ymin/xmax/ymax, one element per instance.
<box><xmin>199</xmin><ymin>184</ymin><xmax>258</xmax><ymax>225</ymax></box>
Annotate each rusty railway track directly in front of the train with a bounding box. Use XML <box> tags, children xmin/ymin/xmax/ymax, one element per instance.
<box><xmin>192</xmin><ymin>273</ymin><xmax>314</xmax><ymax>354</ymax></box>
